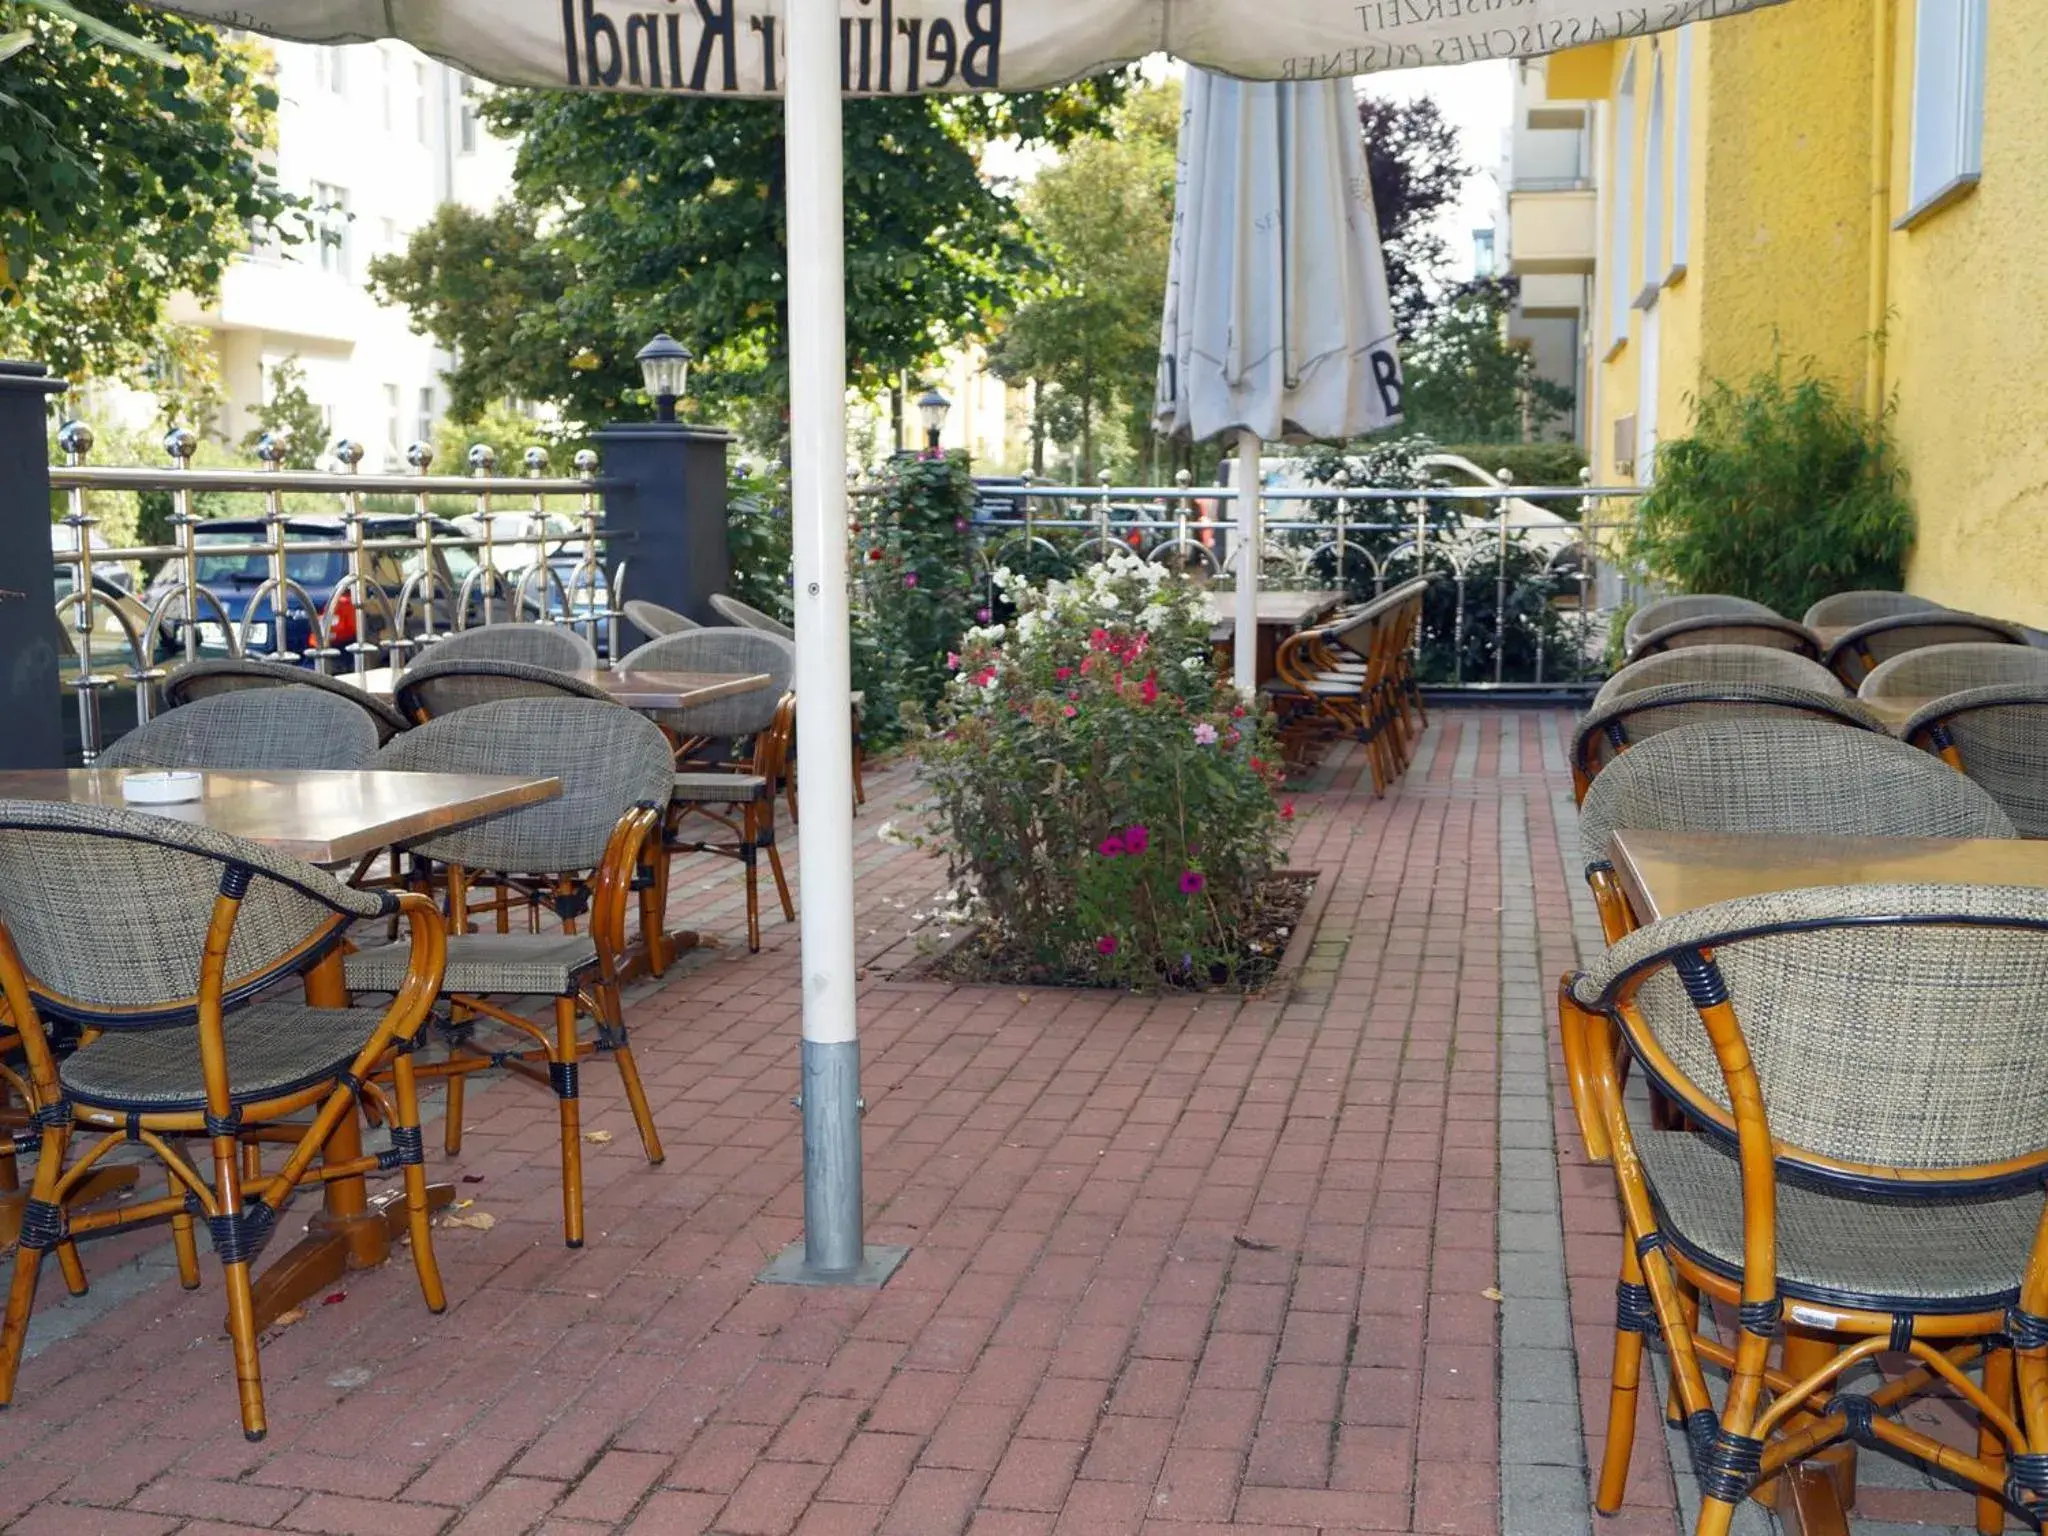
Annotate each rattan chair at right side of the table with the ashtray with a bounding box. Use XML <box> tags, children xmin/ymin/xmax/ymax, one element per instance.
<box><xmin>346</xmin><ymin>698</ymin><xmax>676</xmax><ymax>1247</ymax></box>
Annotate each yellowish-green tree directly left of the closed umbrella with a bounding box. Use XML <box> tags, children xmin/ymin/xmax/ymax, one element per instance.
<box><xmin>989</xmin><ymin>84</ymin><xmax>1180</xmax><ymax>477</ymax></box>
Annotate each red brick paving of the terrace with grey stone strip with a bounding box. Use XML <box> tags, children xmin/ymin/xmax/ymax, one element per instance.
<box><xmin>0</xmin><ymin>711</ymin><xmax>1968</xmax><ymax>1536</ymax></box>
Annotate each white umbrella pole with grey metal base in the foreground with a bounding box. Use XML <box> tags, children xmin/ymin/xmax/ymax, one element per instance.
<box><xmin>762</xmin><ymin>0</ymin><xmax>903</xmax><ymax>1286</ymax></box>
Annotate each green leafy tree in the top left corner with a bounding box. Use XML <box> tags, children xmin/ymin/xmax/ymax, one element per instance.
<box><xmin>0</xmin><ymin>0</ymin><xmax>301</xmax><ymax>379</ymax></box>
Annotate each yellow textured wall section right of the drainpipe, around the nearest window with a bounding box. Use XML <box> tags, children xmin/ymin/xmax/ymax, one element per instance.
<box><xmin>1875</xmin><ymin>0</ymin><xmax>2048</xmax><ymax>627</ymax></box>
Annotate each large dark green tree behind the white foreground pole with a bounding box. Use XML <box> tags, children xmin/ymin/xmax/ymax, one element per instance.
<box><xmin>371</xmin><ymin>78</ymin><xmax>1122</xmax><ymax>442</ymax></box>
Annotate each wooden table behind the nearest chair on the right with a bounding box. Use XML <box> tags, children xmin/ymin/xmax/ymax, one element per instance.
<box><xmin>1608</xmin><ymin>831</ymin><xmax>2048</xmax><ymax>1536</ymax></box>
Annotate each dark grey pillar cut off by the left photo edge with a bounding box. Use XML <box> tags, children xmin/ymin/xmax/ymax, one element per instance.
<box><xmin>0</xmin><ymin>362</ymin><xmax>63</xmax><ymax>768</ymax></box>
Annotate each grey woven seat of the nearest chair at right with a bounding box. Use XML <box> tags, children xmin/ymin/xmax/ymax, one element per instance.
<box><xmin>1636</xmin><ymin>1130</ymin><xmax>2042</xmax><ymax>1313</ymax></box>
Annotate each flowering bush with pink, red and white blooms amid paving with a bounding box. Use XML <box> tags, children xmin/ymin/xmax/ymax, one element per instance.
<box><xmin>920</xmin><ymin>555</ymin><xmax>1303</xmax><ymax>987</ymax></box>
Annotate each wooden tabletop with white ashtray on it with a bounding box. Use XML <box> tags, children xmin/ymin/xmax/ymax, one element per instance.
<box><xmin>0</xmin><ymin>768</ymin><xmax>561</xmax><ymax>864</ymax></box>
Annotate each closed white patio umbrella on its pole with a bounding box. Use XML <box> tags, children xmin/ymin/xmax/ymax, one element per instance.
<box><xmin>1155</xmin><ymin>70</ymin><xmax>1401</xmax><ymax>694</ymax></box>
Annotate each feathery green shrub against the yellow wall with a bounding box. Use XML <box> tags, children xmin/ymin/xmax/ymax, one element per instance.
<box><xmin>1630</xmin><ymin>367</ymin><xmax>1913</xmax><ymax>618</ymax></box>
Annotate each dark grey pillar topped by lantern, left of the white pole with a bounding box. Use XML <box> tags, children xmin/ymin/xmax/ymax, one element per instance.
<box><xmin>596</xmin><ymin>422</ymin><xmax>733</xmax><ymax>643</ymax></box>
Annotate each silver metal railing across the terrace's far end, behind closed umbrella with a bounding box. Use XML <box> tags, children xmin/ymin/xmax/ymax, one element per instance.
<box><xmin>856</xmin><ymin>473</ymin><xmax>1642</xmax><ymax>690</ymax></box>
